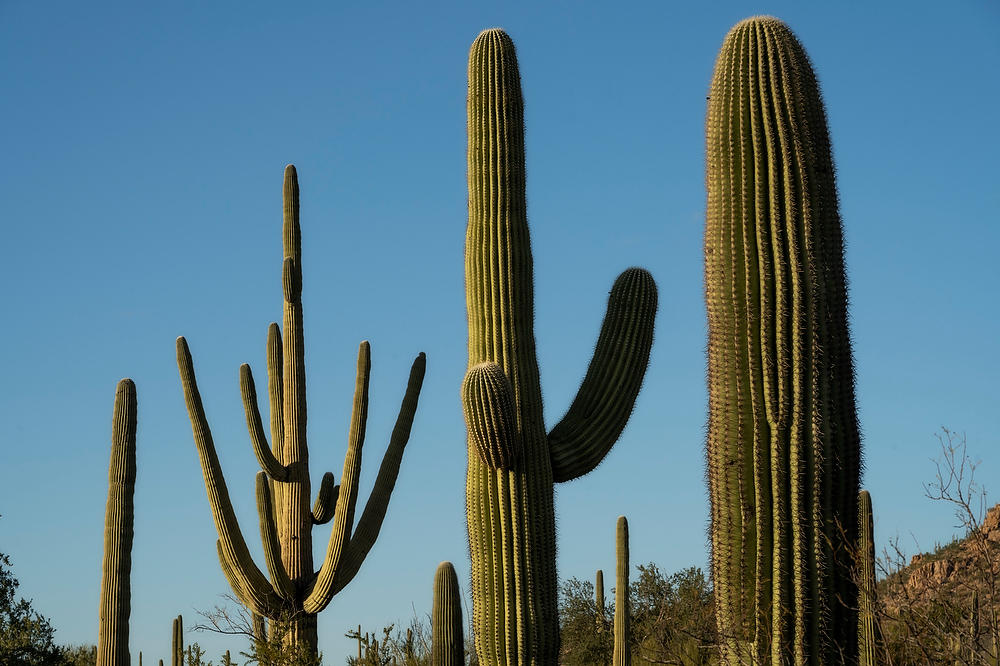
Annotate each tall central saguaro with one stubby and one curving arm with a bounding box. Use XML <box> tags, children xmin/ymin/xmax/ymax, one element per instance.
<box><xmin>462</xmin><ymin>29</ymin><xmax>656</xmax><ymax>664</ymax></box>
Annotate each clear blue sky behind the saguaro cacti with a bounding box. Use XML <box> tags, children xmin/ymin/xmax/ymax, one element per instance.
<box><xmin>0</xmin><ymin>0</ymin><xmax>1000</xmax><ymax>664</ymax></box>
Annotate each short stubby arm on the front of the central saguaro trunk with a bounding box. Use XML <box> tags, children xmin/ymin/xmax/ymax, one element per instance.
<box><xmin>462</xmin><ymin>361</ymin><xmax>520</xmax><ymax>470</ymax></box>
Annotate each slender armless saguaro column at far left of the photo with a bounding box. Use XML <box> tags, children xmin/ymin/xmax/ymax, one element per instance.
<box><xmin>97</xmin><ymin>379</ymin><xmax>136</xmax><ymax>666</ymax></box>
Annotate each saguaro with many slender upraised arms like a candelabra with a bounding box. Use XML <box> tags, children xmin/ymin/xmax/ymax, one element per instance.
<box><xmin>177</xmin><ymin>165</ymin><xmax>425</xmax><ymax>654</ymax></box>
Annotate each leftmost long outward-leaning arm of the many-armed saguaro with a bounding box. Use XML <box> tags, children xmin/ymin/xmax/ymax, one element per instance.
<box><xmin>177</xmin><ymin>337</ymin><xmax>276</xmax><ymax>605</ymax></box>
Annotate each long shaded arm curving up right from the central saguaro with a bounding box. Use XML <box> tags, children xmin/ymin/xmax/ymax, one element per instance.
<box><xmin>549</xmin><ymin>268</ymin><xmax>657</xmax><ymax>482</ymax></box>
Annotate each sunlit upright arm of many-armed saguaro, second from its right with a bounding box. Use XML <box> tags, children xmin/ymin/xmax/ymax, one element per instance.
<box><xmin>303</xmin><ymin>340</ymin><xmax>372</xmax><ymax>613</ymax></box>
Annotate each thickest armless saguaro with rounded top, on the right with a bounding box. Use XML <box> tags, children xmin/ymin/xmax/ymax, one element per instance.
<box><xmin>705</xmin><ymin>17</ymin><xmax>861</xmax><ymax>664</ymax></box>
